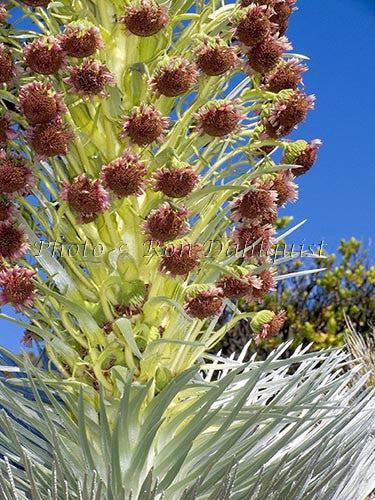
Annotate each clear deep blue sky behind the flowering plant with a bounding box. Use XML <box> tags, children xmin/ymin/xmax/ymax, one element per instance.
<box><xmin>0</xmin><ymin>0</ymin><xmax>375</xmax><ymax>350</ymax></box>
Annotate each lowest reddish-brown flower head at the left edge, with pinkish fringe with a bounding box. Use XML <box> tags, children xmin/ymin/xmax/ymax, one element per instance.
<box><xmin>0</xmin><ymin>266</ymin><xmax>36</xmax><ymax>312</ymax></box>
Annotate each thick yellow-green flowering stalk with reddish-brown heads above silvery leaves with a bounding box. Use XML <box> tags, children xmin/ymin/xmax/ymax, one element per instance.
<box><xmin>0</xmin><ymin>0</ymin><xmax>320</xmax><ymax>392</ymax></box>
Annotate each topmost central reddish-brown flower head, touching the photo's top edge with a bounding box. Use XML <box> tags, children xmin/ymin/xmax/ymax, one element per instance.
<box><xmin>120</xmin><ymin>0</ymin><xmax>168</xmax><ymax>37</ymax></box>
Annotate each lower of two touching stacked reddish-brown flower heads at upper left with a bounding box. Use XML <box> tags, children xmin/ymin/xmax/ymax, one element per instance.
<box><xmin>26</xmin><ymin>117</ymin><xmax>75</xmax><ymax>160</ymax></box>
